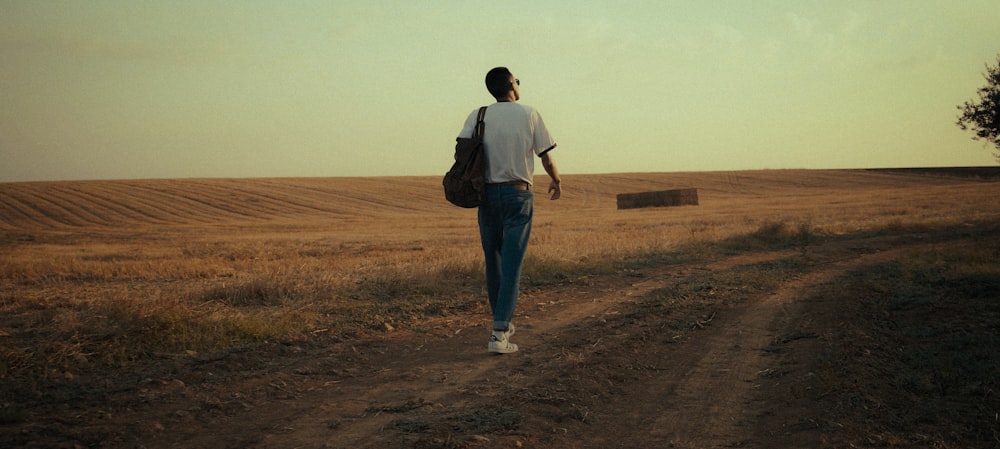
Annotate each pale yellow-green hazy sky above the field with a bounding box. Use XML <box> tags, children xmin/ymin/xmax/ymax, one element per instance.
<box><xmin>0</xmin><ymin>0</ymin><xmax>1000</xmax><ymax>182</ymax></box>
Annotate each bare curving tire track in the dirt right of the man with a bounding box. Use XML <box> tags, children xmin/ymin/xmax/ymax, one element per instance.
<box><xmin>622</xmin><ymin>242</ymin><xmax>928</xmax><ymax>448</ymax></box>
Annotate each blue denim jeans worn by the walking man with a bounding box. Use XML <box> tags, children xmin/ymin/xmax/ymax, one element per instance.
<box><xmin>479</xmin><ymin>185</ymin><xmax>535</xmax><ymax>330</ymax></box>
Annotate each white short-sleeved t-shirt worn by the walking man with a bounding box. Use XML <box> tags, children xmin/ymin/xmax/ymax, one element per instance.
<box><xmin>458</xmin><ymin>102</ymin><xmax>556</xmax><ymax>184</ymax></box>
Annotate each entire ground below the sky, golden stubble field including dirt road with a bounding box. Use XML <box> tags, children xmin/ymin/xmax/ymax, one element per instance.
<box><xmin>0</xmin><ymin>170</ymin><xmax>1000</xmax><ymax>448</ymax></box>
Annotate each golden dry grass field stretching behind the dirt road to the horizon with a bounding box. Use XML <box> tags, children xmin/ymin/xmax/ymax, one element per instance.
<box><xmin>0</xmin><ymin>171</ymin><xmax>1000</xmax><ymax>379</ymax></box>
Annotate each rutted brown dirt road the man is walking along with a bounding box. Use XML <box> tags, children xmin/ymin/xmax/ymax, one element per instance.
<box><xmin>7</xmin><ymin>224</ymin><xmax>1000</xmax><ymax>449</ymax></box>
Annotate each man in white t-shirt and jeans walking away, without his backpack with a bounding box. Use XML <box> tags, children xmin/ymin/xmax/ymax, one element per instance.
<box><xmin>459</xmin><ymin>67</ymin><xmax>562</xmax><ymax>354</ymax></box>
